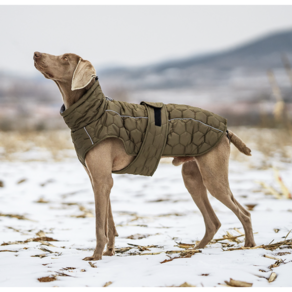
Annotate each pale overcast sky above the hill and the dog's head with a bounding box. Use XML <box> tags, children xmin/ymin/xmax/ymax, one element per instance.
<box><xmin>0</xmin><ymin>6</ymin><xmax>292</xmax><ymax>74</ymax></box>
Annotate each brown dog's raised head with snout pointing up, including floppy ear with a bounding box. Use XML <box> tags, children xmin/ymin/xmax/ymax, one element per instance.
<box><xmin>33</xmin><ymin>52</ymin><xmax>96</xmax><ymax>91</ymax></box>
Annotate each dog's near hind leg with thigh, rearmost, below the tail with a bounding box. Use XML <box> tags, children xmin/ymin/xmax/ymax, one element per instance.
<box><xmin>196</xmin><ymin>137</ymin><xmax>256</xmax><ymax>247</ymax></box>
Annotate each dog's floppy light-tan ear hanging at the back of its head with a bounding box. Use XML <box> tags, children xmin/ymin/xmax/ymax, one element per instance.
<box><xmin>71</xmin><ymin>58</ymin><xmax>96</xmax><ymax>91</ymax></box>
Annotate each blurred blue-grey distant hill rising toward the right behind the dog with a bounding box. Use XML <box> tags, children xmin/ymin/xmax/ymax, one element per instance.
<box><xmin>100</xmin><ymin>30</ymin><xmax>292</xmax><ymax>89</ymax></box>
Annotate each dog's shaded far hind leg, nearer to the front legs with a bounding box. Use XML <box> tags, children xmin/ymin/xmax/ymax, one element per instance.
<box><xmin>182</xmin><ymin>161</ymin><xmax>221</xmax><ymax>248</ymax></box>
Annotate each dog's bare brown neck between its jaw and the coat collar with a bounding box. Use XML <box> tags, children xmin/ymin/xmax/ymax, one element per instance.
<box><xmin>55</xmin><ymin>79</ymin><xmax>95</xmax><ymax>109</ymax></box>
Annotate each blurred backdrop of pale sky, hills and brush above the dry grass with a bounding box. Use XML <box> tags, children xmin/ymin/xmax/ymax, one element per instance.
<box><xmin>0</xmin><ymin>6</ymin><xmax>292</xmax><ymax>160</ymax></box>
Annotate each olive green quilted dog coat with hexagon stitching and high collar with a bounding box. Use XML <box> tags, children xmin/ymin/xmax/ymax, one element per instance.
<box><xmin>60</xmin><ymin>81</ymin><xmax>227</xmax><ymax>176</ymax></box>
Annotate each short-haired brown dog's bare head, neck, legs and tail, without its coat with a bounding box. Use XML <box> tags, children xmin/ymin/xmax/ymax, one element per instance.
<box><xmin>33</xmin><ymin>52</ymin><xmax>256</xmax><ymax>260</ymax></box>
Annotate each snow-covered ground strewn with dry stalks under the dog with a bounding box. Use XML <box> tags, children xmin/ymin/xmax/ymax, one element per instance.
<box><xmin>0</xmin><ymin>149</ymin><xmax>292</xmax><ymax>287</ymax></box>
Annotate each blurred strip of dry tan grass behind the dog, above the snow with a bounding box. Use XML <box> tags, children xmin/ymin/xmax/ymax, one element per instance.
<box><xmin>0</xmin><ymin>127</ymin><xmax>292</xmax><ymax>164</ymax></box>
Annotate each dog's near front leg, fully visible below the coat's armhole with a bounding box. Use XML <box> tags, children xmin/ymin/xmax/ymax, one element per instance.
<box><xmin>84</xmin><ymin>149</ymin><xmax>113</xmax><ymax>260</ymax></box>
